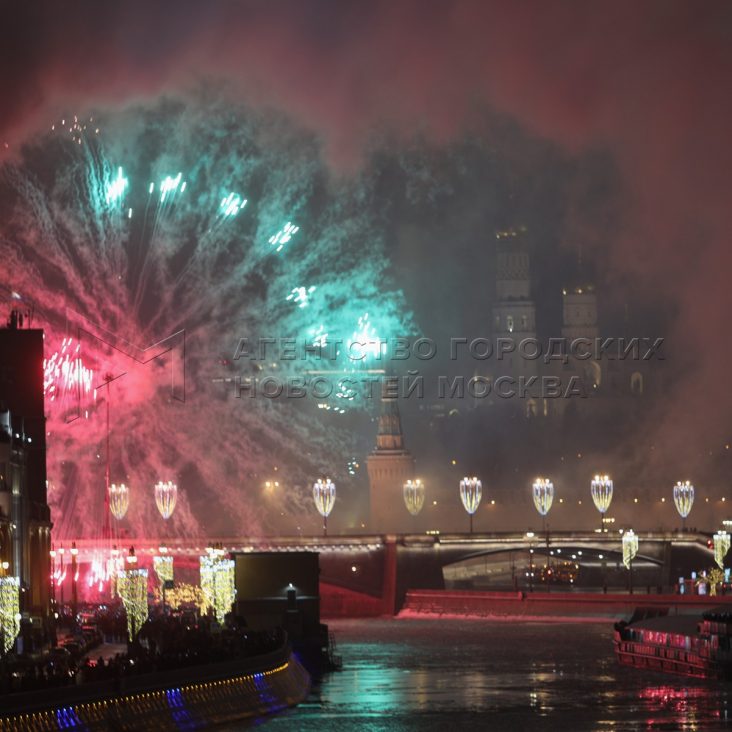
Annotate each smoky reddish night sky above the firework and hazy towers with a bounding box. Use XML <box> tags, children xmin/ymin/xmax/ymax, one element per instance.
<box><xmin>0</xmin><ymin>0</ymin><xmax>732</xmax><ymax>531</ymax></box>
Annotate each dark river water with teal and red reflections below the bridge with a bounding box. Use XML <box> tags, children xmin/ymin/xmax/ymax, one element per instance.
<box><xmin>264</xmin><ymin>620</ymin><xmax>732</xmax><ymax>732</ymax></box>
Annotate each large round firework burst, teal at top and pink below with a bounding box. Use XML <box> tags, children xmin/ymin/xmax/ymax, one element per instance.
<box><xmin>0</xmin><ymin>97</ymin><xmax>411</xmax><ymax>536</ymax></box>
